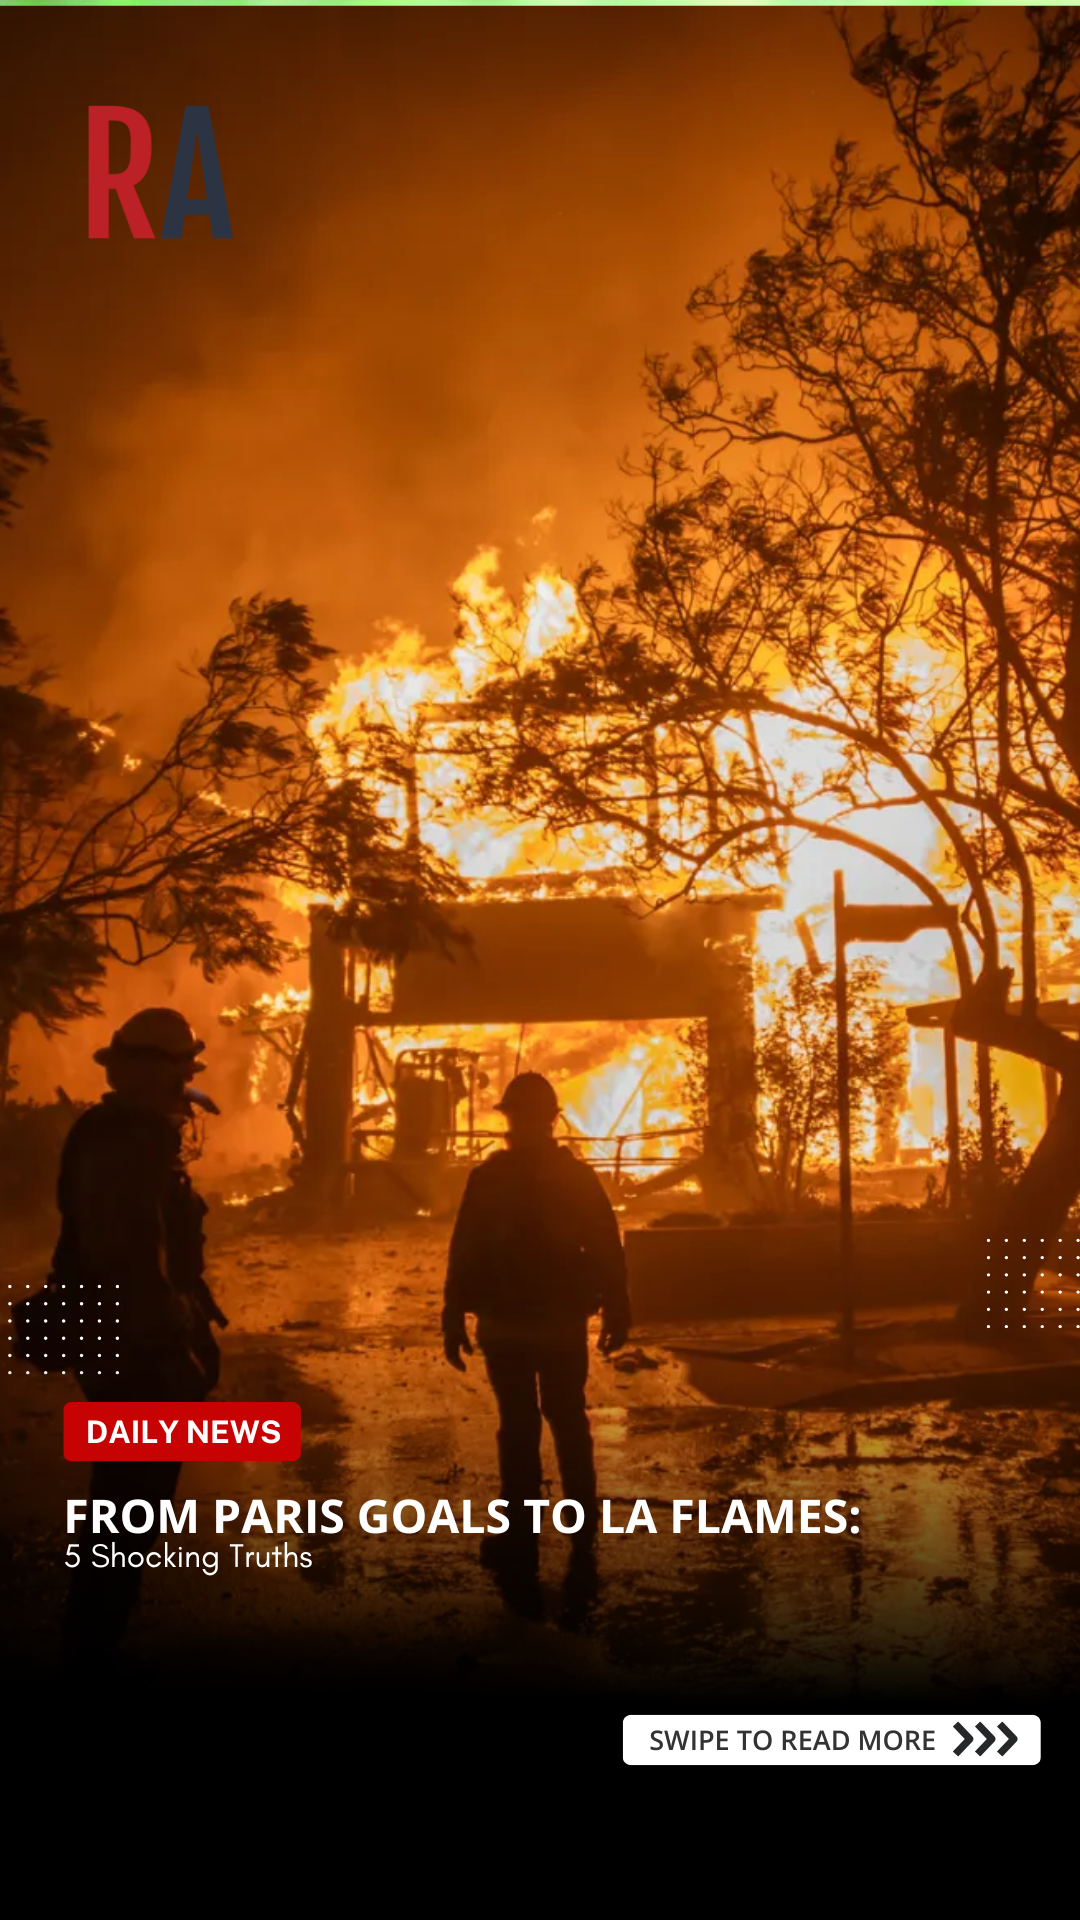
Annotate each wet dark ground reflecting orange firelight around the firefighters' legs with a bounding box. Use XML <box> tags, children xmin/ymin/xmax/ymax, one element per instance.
<box><xmin>0</xmin><ymin>1223</ymin><xmax>1080</xmax><ymax>1758</ymax></box>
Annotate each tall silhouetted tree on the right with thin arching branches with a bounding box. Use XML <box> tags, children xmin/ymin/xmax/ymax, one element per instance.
<box><xmin>457</xmin><ymin>8</ymin><xmax>1080</xmax><ymax>1320</ymax></box>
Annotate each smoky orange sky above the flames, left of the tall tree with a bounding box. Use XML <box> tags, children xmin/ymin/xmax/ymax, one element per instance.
<box><xmin>0</xmin><ymin>10</ymin><xmax>907</xmax><ymax>730</ymax></box>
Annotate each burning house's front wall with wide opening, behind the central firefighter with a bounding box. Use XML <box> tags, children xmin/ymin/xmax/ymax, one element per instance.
<box><xmin>304</xmin><ymin>893</ymin><xmax>776</xmax><ymax>1210</ymax></box>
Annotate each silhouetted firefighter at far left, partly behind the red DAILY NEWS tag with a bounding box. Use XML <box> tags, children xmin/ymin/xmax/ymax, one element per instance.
<box><xmin>46</xmin><ymin>1006</ymin><xmax>225</xmax><ymax>1665</ymax></box>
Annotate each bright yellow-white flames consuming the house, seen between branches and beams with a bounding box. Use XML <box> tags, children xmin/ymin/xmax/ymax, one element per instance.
<box><xmin>261</xmin><ymin>547</ymin><xmax>1053</xmax><ymax>1156</ymax></box>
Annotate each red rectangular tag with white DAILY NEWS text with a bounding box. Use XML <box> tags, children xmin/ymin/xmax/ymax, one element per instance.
<box><xmin>63</xmin><ymin>1400</ymin><xmax>300</xmax><ymax>1459</ymax></box>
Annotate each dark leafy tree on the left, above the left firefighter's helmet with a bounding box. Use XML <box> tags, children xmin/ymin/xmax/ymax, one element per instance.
<box><xmin>0</xmin><ymin>336</ymin><xmax>455</xmax><ymax>1087</ymax></box>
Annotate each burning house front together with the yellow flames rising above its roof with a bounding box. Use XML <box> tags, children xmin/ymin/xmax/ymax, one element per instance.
<box><xmin>216</xmin><ymin>553</ymin><xmax>780</xmax><ymax>1212</ymax></box>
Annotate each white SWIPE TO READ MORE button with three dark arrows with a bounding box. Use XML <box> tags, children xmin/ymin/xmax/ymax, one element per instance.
<box><xmin>623</xmin><ymin>1709</ymin><xmax>1042</xmax><ymax>1772</ymax></box>
